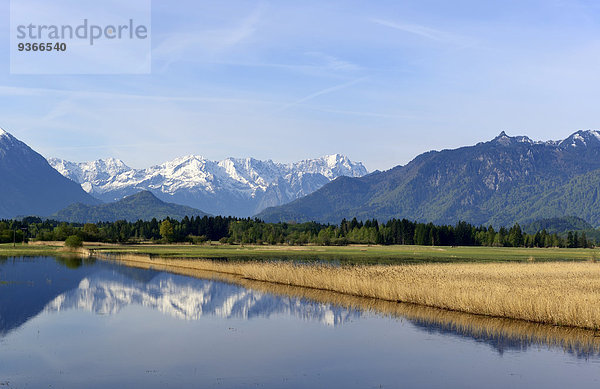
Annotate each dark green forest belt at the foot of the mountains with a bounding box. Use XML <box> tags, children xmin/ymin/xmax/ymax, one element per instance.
<box><xmin>0</xmin><ymin>216</ymin><xmax>596</xmax><ymax>248</ymax></box>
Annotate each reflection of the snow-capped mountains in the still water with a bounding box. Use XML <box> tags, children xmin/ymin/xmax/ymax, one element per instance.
<box><xmin>45</xmin><ymin>271</ymin><xmax>361</xmax><ymax>326</ymax></box>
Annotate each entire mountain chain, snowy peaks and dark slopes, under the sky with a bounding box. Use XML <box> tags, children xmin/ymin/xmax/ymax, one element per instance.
<box><xmin>0</xmin><ymin>124</ymin><xmax>600</xmax><ymax>227</ymax></box>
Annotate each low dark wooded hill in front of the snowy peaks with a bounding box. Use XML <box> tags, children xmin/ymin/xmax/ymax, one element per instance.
<box><xmin>50</xmin><ymin>191</ymin><xmax>207</xmax><ymax>223</ymax></box>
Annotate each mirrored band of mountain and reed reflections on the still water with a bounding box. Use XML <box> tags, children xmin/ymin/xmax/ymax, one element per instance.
<box><xmin>0</xmin><ymin>258</ymin><xmax>600</xmax><ymax>359</ymax></box>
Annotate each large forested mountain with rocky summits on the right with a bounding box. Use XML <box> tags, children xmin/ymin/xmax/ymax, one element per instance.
<box><xmin>257</xmin><ymin>130</ymin><xmax>600</xmax><ymax>226</ymax></box>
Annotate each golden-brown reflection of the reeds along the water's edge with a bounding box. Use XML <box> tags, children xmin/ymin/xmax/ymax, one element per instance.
<box><xmin>104</xmin><ymin>256</ymin><xmax>600</xmax><ymax>355</ymax></box>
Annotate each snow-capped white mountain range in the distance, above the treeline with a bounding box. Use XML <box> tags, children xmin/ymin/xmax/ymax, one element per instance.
<box><xmin>48</xmin><ymin>154</ymin><xmax>367</xmax><ymax>217</ymax></box>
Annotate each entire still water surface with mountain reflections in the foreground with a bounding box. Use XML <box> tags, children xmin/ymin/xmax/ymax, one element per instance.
<box><xmin>0</xmin><ymin>257</ymin><xmax>600</xmax><ymax>388</ymax></box>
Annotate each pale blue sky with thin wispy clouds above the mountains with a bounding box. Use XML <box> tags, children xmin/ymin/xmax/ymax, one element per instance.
<box><xmin>0</xmin><ymin>0</ymin><xmax>600</xmax><ymax>170</ymax></box>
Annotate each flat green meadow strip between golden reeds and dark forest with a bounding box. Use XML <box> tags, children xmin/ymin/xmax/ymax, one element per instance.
<box><xmin>88</xmin><ymin>244</ymin><xmax>600</xmax><ymax>264</ymax></box>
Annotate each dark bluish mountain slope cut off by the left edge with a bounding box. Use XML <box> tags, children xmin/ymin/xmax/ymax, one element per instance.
<box><xmin>0</xmin><ymin>128</ymin><xmax>100</xmax><ymax>218</ymax></box>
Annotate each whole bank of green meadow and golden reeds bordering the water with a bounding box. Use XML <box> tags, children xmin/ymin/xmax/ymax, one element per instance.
<box><xmin>0</xmin><ymin>242</ymin><xmax>600</xmax><ymax>331</ymax></box>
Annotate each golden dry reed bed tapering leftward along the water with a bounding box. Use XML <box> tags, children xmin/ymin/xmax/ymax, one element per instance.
<box><xmin>94</xmin><ymin>255</ymin><xmax>600</xmax><ymax>330</ymax></box>
